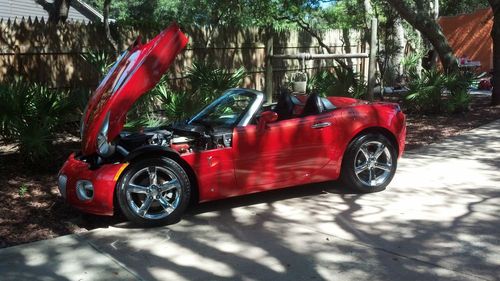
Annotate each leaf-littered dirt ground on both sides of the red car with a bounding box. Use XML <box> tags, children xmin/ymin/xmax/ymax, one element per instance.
<box><xmin>0</xmin><ymin>96</ymin><xmax>500</xmax><ymax>248</ymax></box>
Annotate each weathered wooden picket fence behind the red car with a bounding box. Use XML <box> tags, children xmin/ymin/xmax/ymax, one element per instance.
<box><xmin>0</xmin><ymin>19</ymin><xmax>367</xmax><ymax>90</ymax></box>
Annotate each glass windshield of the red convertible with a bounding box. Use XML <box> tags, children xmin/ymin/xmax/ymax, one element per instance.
<box><xmin>189</xmin><ymin>90</ymin><xmax>256</xmax><ymax>127</ymax></box>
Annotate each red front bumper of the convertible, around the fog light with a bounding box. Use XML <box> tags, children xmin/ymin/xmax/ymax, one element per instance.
<box><xmin>58</xmin><ymin>154</ymin><xmax>127</xmax><ymax>216</ymax></box>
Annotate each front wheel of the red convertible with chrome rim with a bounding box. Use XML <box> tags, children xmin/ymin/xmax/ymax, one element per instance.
<box><xmin>117</xmin><ymin>157</ymin><xmax>191</xmax><ymax>227</ymax></box>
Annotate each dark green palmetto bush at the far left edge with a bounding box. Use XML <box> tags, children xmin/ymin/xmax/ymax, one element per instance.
<box><xmin>0</xmin><ymin>78</ymin><xmax>73</xmax><ymax>163</ymax></box>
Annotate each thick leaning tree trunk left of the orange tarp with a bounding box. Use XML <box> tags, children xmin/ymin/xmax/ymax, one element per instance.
<box><xmin>387</xmin><ymin>0</ymin><xmax>458</xmax><ymax>72</ymax></box>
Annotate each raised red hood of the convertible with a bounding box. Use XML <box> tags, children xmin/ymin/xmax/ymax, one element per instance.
<box><xmin>81</xmin><ymin>24</ymin><xmax>188</xmax><ymax>155</ymax></box>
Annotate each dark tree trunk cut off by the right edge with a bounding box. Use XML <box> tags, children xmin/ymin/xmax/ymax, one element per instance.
<box><xmin>488</xmin><ymin>0</ymin><xmax>500</xmax><ymax>105</ymax></box>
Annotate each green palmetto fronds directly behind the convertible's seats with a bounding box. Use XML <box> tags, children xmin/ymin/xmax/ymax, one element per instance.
<box><xmin>308</xmin><ymin>66</ymin><xmax>366</xmax><ymax>98</ymax></box>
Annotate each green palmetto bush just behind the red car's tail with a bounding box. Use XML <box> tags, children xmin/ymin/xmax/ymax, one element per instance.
<box><xmin>405</xmin><ymin>69</ymin><xmax>472</xmax><ymax>113</ymax></box>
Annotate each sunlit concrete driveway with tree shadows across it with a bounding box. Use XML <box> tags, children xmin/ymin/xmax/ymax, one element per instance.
<box><xmin>0</xmin><ymin>120</ymin><xmax>500</xmax><ymax>281</ymax></box>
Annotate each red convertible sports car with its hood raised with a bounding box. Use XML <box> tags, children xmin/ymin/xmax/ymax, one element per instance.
<box><xmin>58</xmin><ymin>25</ymin><xmax>406</xmax><ymax>225</ymax></box>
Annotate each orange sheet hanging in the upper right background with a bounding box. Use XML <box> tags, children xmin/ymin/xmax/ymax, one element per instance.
<box><xmin>438</xmin><ymin>9</ymin><xmax>493</xmax><ymax>71</ymax></box>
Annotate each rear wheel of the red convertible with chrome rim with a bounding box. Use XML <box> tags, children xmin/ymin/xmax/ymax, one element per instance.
<box><xmin>340</xmin><ymin>133</ymin><xmax>398</xmax><ymax>193</ymax></box>
